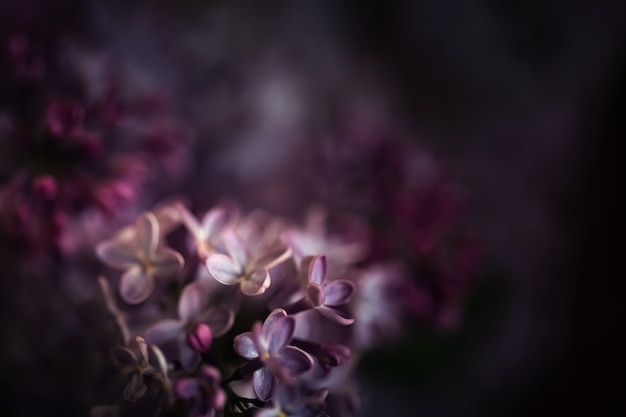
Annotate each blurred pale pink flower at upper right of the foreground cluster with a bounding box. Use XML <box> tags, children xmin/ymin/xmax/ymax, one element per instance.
<box><xmin>282</xmin><ymin>208</ymin><xmax>368</xmax><ymax>265</ymax></box>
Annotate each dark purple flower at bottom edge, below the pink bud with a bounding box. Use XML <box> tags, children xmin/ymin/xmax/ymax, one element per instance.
<box><xmin>176</xmin><ymin>365</ymin><xmax>226</xmax><ymax>417</ymax></box>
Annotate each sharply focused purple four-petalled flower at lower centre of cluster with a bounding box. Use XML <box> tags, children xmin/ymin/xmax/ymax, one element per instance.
<box><xmin>234</xmin><ymin>309</ymin><xmax>313</xmax><ymax>401</ymax></box>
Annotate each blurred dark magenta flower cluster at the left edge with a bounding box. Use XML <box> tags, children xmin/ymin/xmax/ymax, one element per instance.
<box><xmin>0</xmin><ymin>33</ymin><xmax>191</xmax><ymax>252</ymax></box>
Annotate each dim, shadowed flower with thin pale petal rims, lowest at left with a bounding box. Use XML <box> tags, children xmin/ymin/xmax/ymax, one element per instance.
<box><xmin>111</xmin><ymin>337</ymin><xmax>169</xmax><ymax>401</ymax></box>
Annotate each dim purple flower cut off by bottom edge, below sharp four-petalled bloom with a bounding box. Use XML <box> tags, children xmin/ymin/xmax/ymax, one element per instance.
<box><xmin>255</xmin><ymin>385</ymin><xmax>328</xmax><ymax>417</ymax></box>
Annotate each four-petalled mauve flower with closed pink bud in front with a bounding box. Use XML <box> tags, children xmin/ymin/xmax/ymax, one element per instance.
<box><xmin>144</xmin><ymin>282</ymin><xmax>234</xmax><ymax>369</ymax></box>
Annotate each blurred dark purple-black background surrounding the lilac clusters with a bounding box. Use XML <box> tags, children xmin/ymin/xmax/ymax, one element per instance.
<box><xmin>0</xmin><ymin>0</ymin><xmax>626</xmax><ymax>417</ymax></box>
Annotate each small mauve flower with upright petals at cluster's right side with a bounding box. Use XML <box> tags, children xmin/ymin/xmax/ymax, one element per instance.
<box><xmin>306</xmin><ymin>255</ymin><xmax>355</xmax><ymax>325</ymax></box>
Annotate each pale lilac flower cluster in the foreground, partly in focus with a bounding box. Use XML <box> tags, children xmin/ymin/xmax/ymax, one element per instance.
<box><xmin>93</xmin><ymin>202</ymin><xmax>420</xmax><ymax>417</ymax></box>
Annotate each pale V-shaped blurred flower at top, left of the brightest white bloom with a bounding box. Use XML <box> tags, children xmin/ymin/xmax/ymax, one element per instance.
<box><xmin>179</xmin><ymin>204</ymin><xmax>239</xmax><ymax>261</ymax></box>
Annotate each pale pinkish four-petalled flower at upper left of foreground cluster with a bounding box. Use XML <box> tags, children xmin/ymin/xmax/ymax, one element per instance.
<box><xmin>96</xmin><ymin>212</ymin><xmax>184</xmax><ymax>304</ymax></box>
